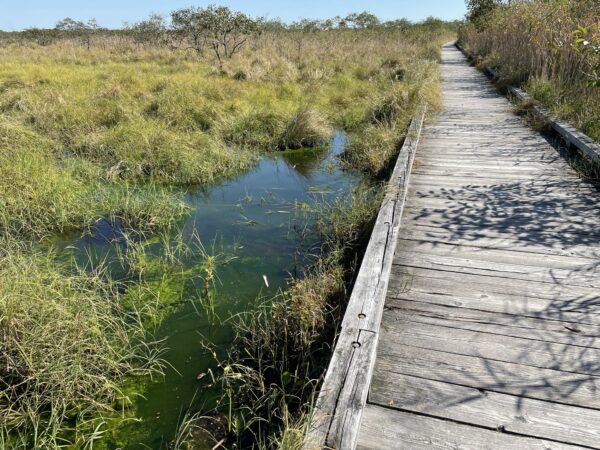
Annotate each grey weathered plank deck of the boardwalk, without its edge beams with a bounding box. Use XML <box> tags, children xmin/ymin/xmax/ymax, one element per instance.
<box><xmin>354</xmin><ymin>45</ymin><xmax>600</xmax><ymax>450</ymax></box>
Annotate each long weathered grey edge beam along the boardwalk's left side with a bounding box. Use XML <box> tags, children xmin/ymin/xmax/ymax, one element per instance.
<box><xmin>305</xmin><ymin>108</ymin><xmax>425</xmax><ymax>450</ymax></box>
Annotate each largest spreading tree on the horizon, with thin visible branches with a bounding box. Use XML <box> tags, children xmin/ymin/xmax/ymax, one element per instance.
<box><xmin>171</xmin><ymin>5</ymin><xmax>259</xmax><ymax>69</ymax></box>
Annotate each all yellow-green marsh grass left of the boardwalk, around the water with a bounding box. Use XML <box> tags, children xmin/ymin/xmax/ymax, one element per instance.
<box><xmin>0</xmin><ymin>23</ymin><xmax>454</xmax><ymax>449</ymax></box>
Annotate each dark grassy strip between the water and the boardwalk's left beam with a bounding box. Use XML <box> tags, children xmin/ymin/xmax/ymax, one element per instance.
<box><xmin>191</xmin><ymin>182</ymin><xmax>382</xmax><ymax>448</ymax></box>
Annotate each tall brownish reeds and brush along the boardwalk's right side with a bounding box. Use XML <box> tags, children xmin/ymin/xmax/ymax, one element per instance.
<box><xmin>460</xmin><ymin>0</ymin><xmax>600</xmax><ymax>141</ymax></box>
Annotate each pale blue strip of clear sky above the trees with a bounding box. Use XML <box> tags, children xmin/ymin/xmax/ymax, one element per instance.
<box><xmin>0</xmin><ymin>0</ymin><xmax>465</xmax><ymax>30</ymax></box>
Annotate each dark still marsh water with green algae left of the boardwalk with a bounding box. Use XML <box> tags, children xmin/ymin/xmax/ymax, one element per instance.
<box><xmin>56</xmin><ymin>133</ymin><xmax>361</xmax><ymax>449</ymax></box>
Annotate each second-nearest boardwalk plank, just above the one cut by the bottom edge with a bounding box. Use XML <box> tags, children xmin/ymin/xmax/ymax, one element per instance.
<box><xmin>369</xmin><ymin>371</ymin><xmax>600</xmax><ymax>448</ymax></box>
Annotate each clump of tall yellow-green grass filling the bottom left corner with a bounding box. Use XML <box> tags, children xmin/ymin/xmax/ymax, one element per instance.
<box><xmin>0</xmin><ymin>237</ymin><xmax>162</xmax><ymax>449</ymax></box>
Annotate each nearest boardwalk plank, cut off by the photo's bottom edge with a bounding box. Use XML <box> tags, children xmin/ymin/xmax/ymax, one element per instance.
<box><xmin>358</xmin><ymin>405</ymin><xmax>580</xmax><ymax>450</ymax></box>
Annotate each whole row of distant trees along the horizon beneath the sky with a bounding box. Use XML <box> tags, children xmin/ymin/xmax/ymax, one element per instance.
<box><xmin>0</xmin><ymin>5</ymin><xmax>458</xmax><ymax>67</ymax></box>
